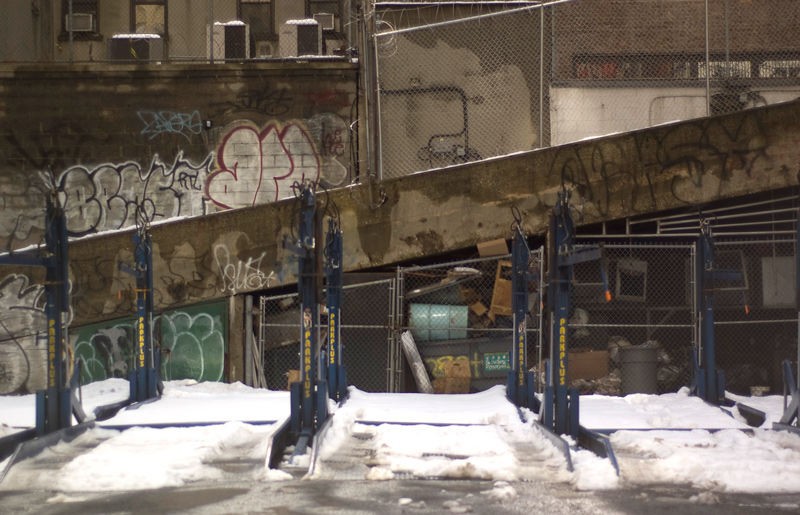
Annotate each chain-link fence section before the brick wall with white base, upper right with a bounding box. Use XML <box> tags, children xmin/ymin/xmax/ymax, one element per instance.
<box><xmin>550</xmin><ymin>0</ymin><xmax>800</xmax><ymax>145</ymax></box>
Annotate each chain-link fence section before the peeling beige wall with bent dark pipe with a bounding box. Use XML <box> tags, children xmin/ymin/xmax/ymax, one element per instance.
<box><xmin>375</xmin><ymin>7</ymin><xmax>543</xmax><ymax>178</ymax></box>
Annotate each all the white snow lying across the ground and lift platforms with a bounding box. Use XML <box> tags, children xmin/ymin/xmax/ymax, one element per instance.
<box><xmin>0</xmin><ymin>379</ymin><xmax>800</xmax><ymax>493</ymax></box>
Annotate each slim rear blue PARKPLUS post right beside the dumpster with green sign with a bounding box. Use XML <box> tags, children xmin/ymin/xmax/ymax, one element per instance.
<box><xmin>506</xmin><ymin>208</ymin><xmax>539</xmax><ymax>411</ymax></box>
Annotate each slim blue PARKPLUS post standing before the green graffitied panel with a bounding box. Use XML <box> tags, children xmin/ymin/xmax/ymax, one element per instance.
<box><xmin>119</xmin><ymin>207</ymin><xmax>164</xmax><ymax>403</ymax></box>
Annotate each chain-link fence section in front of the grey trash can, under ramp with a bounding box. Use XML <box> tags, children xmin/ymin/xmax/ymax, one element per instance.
<box><xmin>568</xmin><ymin>243</ymin><xmax>696</xmax><ymax>395</ymax></box>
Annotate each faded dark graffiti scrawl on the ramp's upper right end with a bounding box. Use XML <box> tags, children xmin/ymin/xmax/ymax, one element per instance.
<box><xmin>548</xmin><ymin>111</ymin><xmax>780</xmax><ymax>222</ymax></box>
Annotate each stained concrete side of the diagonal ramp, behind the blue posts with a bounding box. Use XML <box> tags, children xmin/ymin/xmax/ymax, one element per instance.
<box><xmin>6</xmin><ymin>98</ymin><xmax>800</xmax><ymax>324</ymax></box>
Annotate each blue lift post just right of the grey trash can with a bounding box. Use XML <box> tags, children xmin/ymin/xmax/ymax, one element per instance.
<box><xmin>692</xmin><ymin>220</ymin><xmax>750</xmax><ymax>406</ymax></box>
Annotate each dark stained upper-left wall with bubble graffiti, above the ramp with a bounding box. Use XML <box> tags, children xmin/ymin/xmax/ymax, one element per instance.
<box><xmin>0</xmin><ymin>63</ymin><xmax>357</xmax><ymax>249</ymax></box>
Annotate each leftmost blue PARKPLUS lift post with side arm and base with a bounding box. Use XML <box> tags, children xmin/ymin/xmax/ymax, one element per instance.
<box><xmin>0</xmin><ymin>195</ymin><xmax>86</xmax><ymax>468</ymax></box>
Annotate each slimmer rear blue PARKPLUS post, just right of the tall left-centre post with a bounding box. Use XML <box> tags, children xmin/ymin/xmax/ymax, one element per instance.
<box><xmin>325</xmin><ymin>218</ymin><xmax>347</xmax><ymax>401</ymax></box>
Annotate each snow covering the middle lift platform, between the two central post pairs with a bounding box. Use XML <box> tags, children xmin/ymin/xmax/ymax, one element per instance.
<box><xmin>316</xmin><ymin>386</ymin><xmax>569</xmax><ymax>481</ymax></box>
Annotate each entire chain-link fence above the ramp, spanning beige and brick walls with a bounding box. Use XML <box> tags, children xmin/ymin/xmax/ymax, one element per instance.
<box><xmin>375</xmin><ymin>0</ymin><xmax>800</xmax><ymax>178</ymax></box>
